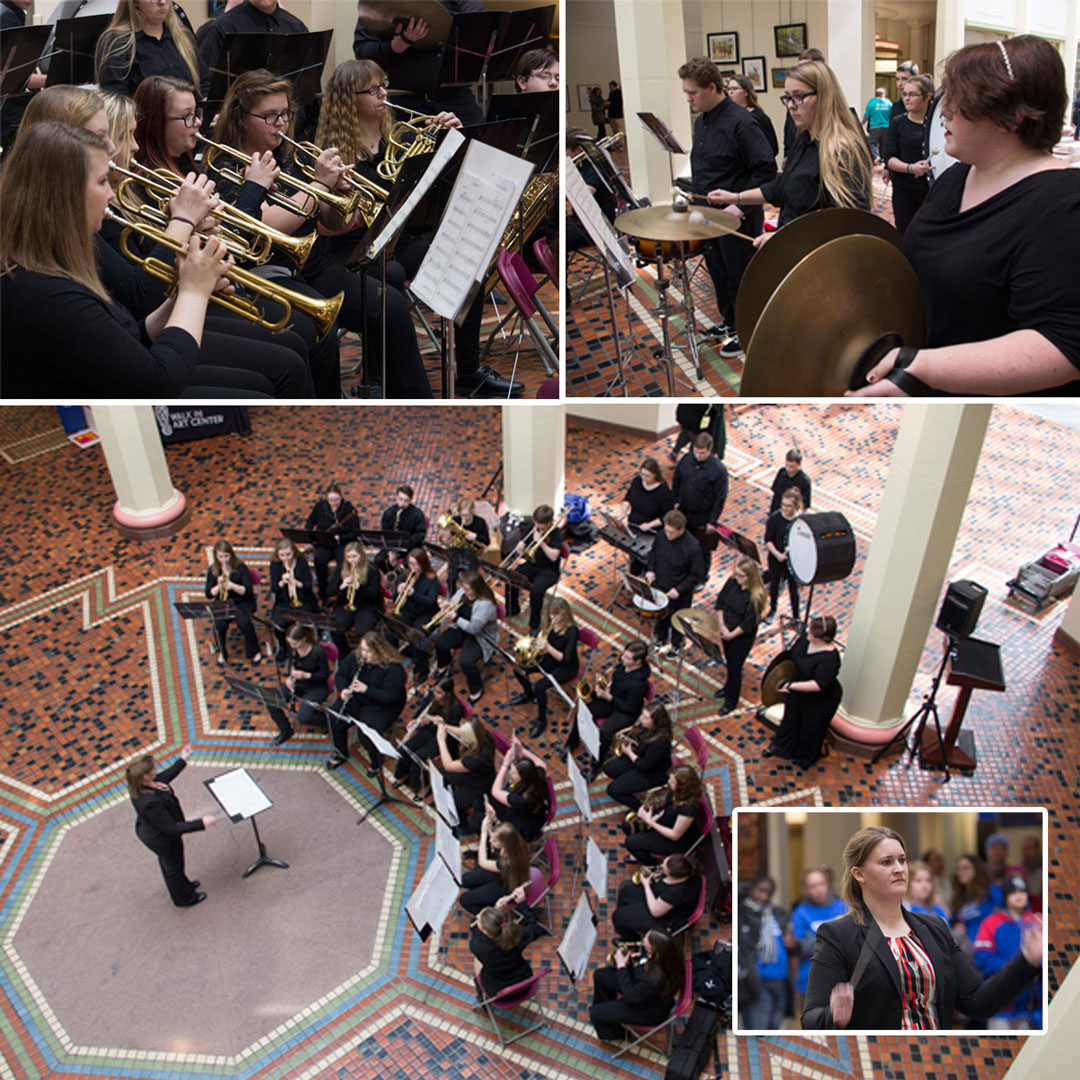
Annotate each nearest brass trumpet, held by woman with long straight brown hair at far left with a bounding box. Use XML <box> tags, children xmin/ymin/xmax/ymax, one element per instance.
<box><xmin>105</xmin><ymin>207</ymin><xmax>345</xmax><ymax>341</ymax></box>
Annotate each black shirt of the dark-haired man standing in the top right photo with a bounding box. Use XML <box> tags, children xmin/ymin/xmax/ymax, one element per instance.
<box><xmin>690</xmin><ymin>97</ymin><xmax>777</xmax><ymax>195</ymax></box>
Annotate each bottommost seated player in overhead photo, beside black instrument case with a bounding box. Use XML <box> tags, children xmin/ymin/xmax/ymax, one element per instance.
<box><xmin>589</xmin><ymin>930</ymin><xmax>686</xmax><ymax>1042</ymax></box>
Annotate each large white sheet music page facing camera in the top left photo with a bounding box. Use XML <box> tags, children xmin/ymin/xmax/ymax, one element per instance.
<box><xmin>410</xmin><ymin>139</ymin><xmax>534</xmax><ymax>319</ymax></box>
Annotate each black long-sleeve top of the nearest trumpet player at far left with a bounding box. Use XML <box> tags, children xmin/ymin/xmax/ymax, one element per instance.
<box><xmin>0</xmin><ymin>267</ymin><xmax>199</xmax><ymax>401</ymax></box>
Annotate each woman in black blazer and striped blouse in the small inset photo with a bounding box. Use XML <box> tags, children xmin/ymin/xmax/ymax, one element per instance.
<box><xmin>802</xmin><ymin>825</ymin><xmax>1042</xmax><ymax>1031</ymax></box>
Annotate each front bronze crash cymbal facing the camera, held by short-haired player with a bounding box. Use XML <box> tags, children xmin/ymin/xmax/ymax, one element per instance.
<box><xmin>739</xmin><ymin>235</ymin><xmax>927</xmax><ymax>397</ymax></box>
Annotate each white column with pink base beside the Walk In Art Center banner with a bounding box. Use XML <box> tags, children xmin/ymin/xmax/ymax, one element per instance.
<box><xmin>93</xmin><ymin>405</ymin><xmax>188</xmax><ymax>539</ymax></box>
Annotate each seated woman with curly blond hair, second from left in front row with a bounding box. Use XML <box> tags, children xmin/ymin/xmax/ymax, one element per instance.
<box><xmin>326</xmin><ymin>630</ymin><xmax>405</xmax><ymax>774</ymax></box>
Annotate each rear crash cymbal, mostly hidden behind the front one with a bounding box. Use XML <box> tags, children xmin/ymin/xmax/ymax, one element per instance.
<box><xmin>735</xmin><ymin>208</ymin><xmax>901</xmax><ymax>342</ymax></box>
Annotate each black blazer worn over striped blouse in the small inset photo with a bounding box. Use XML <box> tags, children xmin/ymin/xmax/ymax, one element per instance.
<box><xmin>802</xmin><ymin>909</ymin><xmax>1041</xmax><ymax>1031</ymax></box>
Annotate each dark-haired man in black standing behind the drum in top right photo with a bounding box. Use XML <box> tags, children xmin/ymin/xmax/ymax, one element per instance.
<box><xmin>678</xmin><ymin>57</ymin><xmax>777</xmax><ymax>356</ymax></box>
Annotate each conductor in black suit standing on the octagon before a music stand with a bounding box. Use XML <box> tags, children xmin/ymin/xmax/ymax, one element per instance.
<box><xmin>125</xmin><ymin>746</ymin><xmax>217</xmax><ymax>907</ymax></box>
